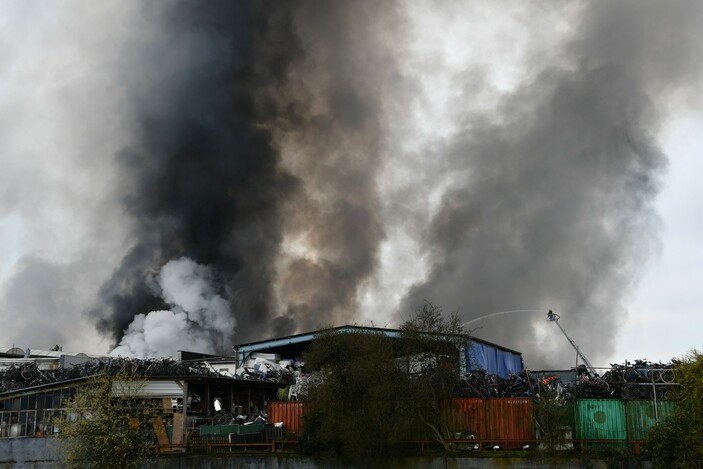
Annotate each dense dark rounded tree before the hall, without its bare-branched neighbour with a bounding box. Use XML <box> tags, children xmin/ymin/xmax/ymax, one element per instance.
<box><xmin>302</xmin><ymin>330</ymin><xmax>407</xmax><ymax>460</ymax></box>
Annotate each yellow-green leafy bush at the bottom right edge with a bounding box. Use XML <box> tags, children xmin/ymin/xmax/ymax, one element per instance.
<box><xmin>647</xmin><ymin>350</ymin><xmax>703</xmax><ymax>468</ymax></box>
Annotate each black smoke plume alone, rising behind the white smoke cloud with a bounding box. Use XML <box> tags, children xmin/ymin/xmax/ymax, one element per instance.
<box><xmin>98</xmin><ymin>2</ymin><xmax>296</xmax><ymax>350</ymax></box>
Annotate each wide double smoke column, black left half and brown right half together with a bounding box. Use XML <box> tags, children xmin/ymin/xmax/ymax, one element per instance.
<box><xmin>95</xmin><ymin>1</ymin><xmax>404</xmax><ymax>352</ymax></box>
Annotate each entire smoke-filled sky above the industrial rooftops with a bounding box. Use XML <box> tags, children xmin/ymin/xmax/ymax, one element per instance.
<box><xmin>0</xmin><ymin>0</ymin><xmax>703</xmax><ymax>368</ymax></box>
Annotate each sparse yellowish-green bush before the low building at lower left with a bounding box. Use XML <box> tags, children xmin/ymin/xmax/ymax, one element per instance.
<box><xmin>59</xmin><ymin>373</ymin><xmax>160</xmax><ymax>468</ymax></box>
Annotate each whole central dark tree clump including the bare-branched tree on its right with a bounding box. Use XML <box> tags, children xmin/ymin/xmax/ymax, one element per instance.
<box><xmin>303</xmin><ymin>303</ymin><xmax>467</xmax><ymax>459</ymax></box>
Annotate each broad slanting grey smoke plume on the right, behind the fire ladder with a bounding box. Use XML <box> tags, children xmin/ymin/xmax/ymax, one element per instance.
<box><xmin>403</xmin><ymin>2</ymin><xmax>703</xmax><ymax>367</ymax></box>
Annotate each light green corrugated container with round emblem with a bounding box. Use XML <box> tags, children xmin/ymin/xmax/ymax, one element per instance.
<box><xmin>575</xmin><ymin>399</ymin><xmax>627</xmax><ymax>446</ymax></box>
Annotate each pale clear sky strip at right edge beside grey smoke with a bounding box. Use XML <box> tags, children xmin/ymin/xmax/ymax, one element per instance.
<box><xmin>612</xmin><ymin>110</ymin><xmax>703</xmax><ymax>366</ymax></box>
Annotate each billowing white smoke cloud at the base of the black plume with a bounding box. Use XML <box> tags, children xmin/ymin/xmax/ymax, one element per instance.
<box><xmin>110</xmin><ymin>257</ymin><xmax>236</xmax><ymax>358</ymax></box>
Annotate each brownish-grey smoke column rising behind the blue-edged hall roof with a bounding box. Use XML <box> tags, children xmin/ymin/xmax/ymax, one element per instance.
<box><xmin>265</xmin><ymin>1</ymin><xmax>404</xmax><ymax>333</ymax></box>
